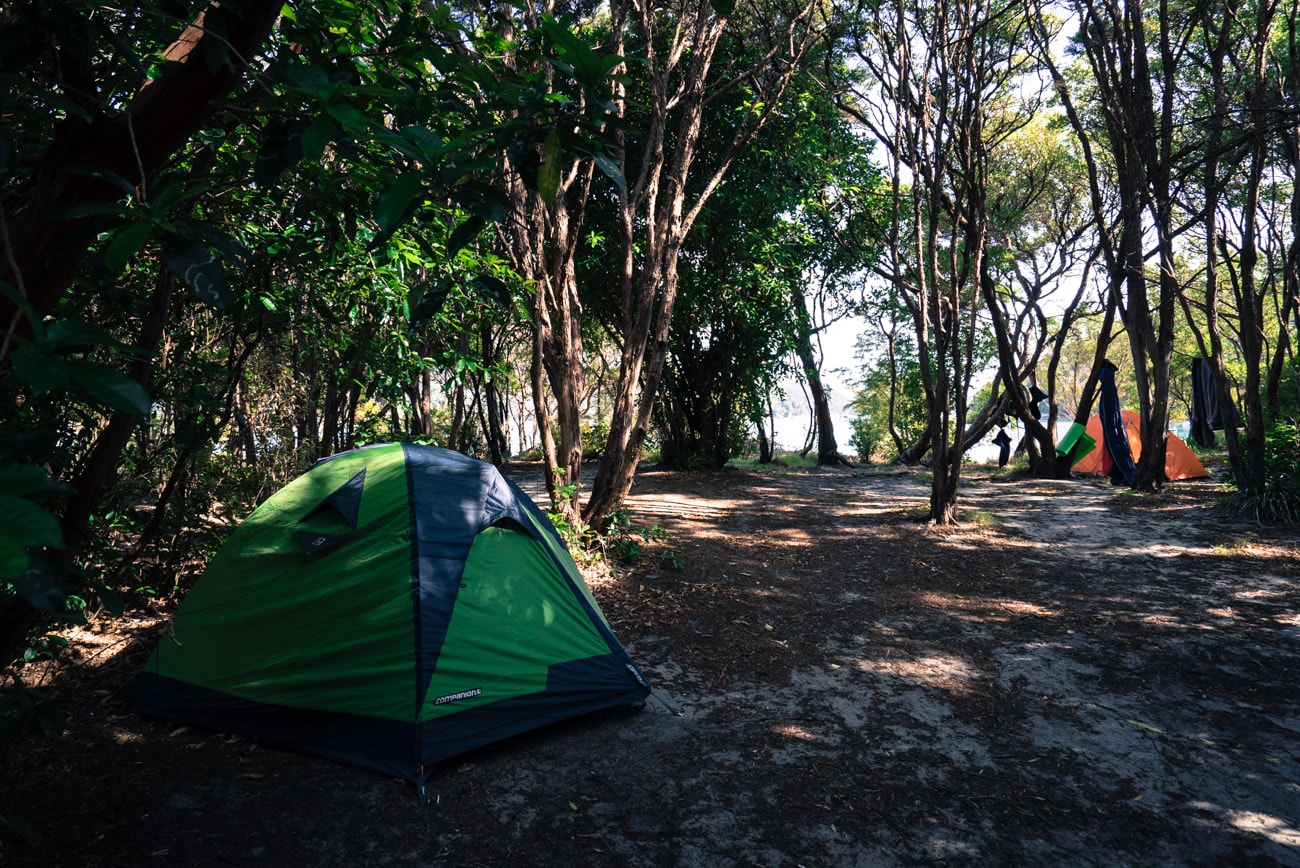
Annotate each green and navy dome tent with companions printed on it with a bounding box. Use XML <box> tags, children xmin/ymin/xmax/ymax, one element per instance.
<box><xmin>133</xmin><ymin>443</ymin><xmax>650</xmax><ymax>793</ymax></box>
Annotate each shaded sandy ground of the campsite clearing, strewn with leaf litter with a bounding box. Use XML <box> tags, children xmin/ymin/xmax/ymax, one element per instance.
<box><xmin>0</xmin><ymin>469</ymin><xmax>1300</xmax><ymax>865</ymax></box>
